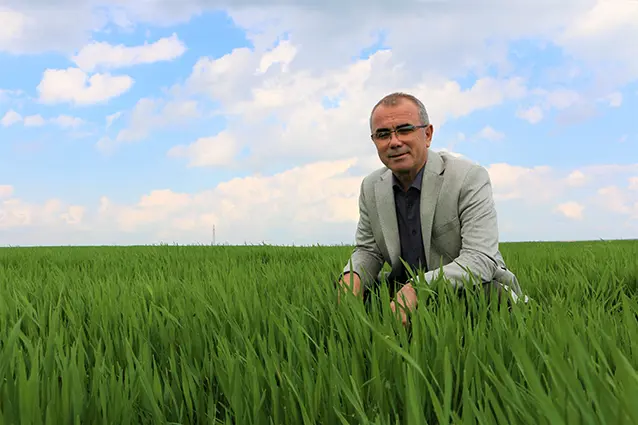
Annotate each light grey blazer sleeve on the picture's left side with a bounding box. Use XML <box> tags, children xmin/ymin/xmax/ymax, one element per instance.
<box><xmin>342</xmin><ymin>179</ymin><xmax>384</xmax><ymax>282</ymax></box>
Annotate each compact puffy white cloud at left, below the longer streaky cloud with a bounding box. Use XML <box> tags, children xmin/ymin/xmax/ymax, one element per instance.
<box><xmin>37</xmin><ymin>68</ymin><xmax>133</xmax><ymax>105</ymax></box>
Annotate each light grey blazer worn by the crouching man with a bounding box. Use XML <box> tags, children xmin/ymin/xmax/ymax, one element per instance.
<box><xmin>343</xmin><ymin>150</ymin><xmax>521</xmax><ymax>301</ymax></box>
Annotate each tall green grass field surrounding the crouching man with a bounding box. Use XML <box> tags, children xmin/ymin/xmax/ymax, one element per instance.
<box><xmin>0</xmin><ymin>241</ymin><xmax>638</xmax><ymax>425</ymax></box>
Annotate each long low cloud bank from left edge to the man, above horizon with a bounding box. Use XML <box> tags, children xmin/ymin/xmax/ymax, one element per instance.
<box><xmin>0</xmin><ymin>159</ymin><xmax>361</xmax><ymax>243</ymax></box>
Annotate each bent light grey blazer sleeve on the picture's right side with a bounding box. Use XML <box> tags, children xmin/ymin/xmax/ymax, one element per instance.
<box><xmin>416</xmin><ymin>165</ymin><xmax>498</xmax><ymax>288</ymax></box>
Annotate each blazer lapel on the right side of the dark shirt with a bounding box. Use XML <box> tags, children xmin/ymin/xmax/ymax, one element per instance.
<box><xmin>420</xmin><ymin>151</ymin><xmax>445</xmax><ymax>269</ymax></box>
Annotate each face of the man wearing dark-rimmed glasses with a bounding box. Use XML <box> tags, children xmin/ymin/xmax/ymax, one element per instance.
<box><xmin>371</xmin><ymin>99</ymin><xmax>434</xmax><ymax>178</ymax></box>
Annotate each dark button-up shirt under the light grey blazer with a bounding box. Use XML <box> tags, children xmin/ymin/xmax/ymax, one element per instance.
<box><xmin>392</xmin><ymin>168</ymin><xmax>427</xmax><ymax>282</ymax></box>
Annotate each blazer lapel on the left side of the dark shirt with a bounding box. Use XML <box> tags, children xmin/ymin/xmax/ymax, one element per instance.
<box><xmin>374</xmin><ymin>170</ymin><xmax>401</xmax><ymax>269</ymax></box>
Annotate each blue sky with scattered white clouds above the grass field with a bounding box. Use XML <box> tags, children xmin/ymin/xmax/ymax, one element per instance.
<box><xmin>0</xmin><ymin>0</ymin><xmax>638</xmax><ymax>245</ymax></box>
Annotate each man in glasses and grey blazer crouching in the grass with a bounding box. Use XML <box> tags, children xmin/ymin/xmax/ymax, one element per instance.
<box><xmin>340</xmin><ymin>93</ymin><xmax>521</xmax><ymax>324</ymax></box>
